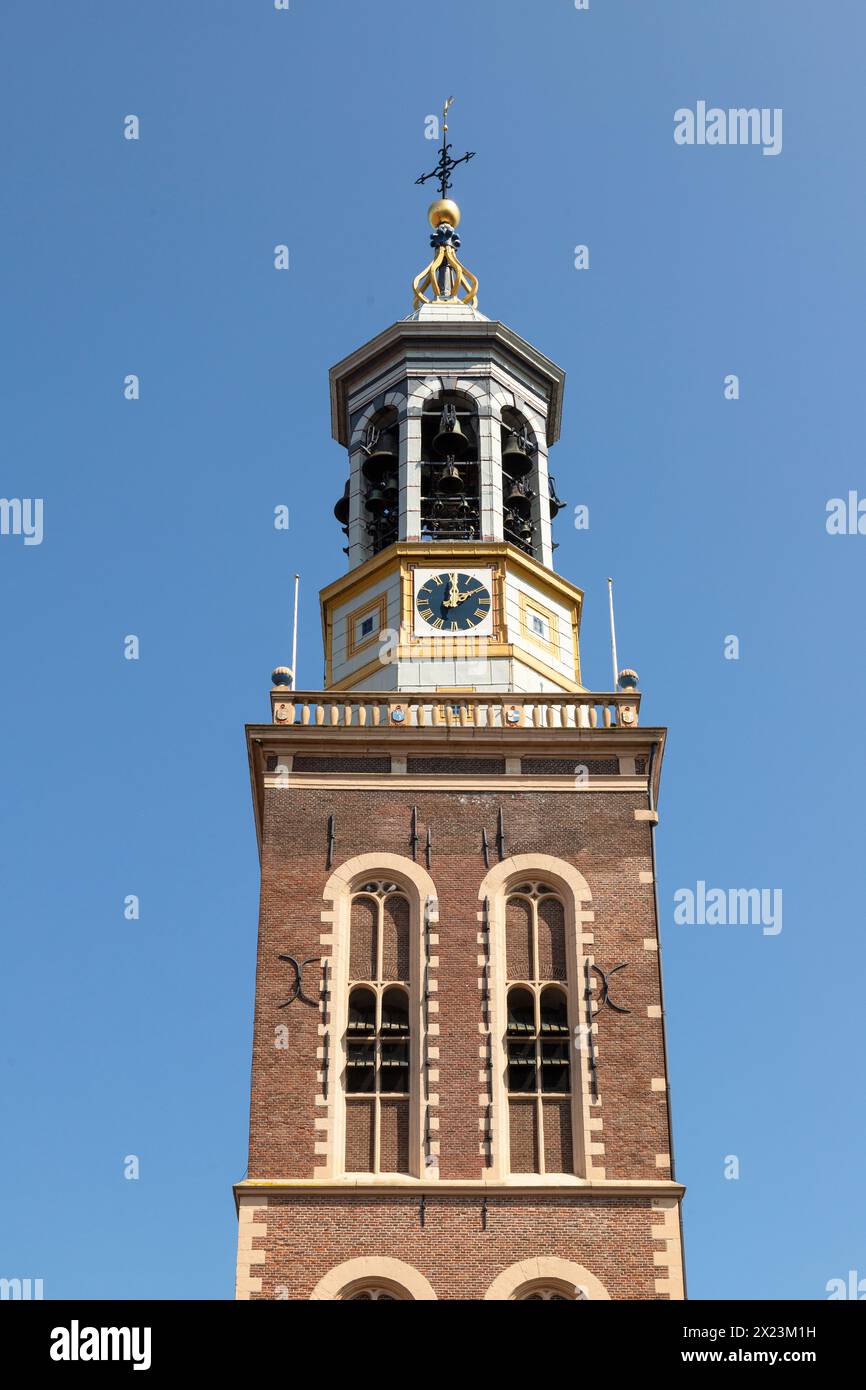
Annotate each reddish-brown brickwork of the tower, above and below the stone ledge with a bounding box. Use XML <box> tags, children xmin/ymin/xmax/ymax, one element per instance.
<box><xmin>239</xmin><ymin>759</ymin><xmax>683</xmax><ymax>1300</ymax></box>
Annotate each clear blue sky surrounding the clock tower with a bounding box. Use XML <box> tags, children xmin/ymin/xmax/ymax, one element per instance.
<box><xmin>0</xmin><ymin>0</ymin><xmax>866</xmax><ymax>1298</ymax></box>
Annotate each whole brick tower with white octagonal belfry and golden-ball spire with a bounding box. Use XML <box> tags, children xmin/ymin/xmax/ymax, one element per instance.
<box><xmin>235</xmin><ymin>130</ymin><xmax>684</xmax><ymax>1301</ymax></box>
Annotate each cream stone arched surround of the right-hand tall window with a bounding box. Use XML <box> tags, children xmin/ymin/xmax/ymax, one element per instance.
<box><xmin>478</xmin><ymin>855</ymin><xmax>596</xmax><ymax>1186</ymax></box>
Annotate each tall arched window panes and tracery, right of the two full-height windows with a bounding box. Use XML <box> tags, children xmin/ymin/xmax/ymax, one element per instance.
<box><xmin>505</xmin><ymin>883</ymin><xmax>574</xmax><ymax>1173</ymax></box>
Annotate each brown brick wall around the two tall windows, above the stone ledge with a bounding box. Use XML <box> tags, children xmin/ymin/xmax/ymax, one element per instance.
<box><xmin>249</xmin><ymin>777</ymin><xmax>669</xmax><ymax>1179</ymax></box>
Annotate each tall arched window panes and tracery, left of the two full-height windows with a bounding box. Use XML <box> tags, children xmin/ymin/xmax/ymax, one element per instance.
<box><xmin>345</xmin><ymin>880</ymin><xmax>413</xmax><ymax>1173</ymax></box>
